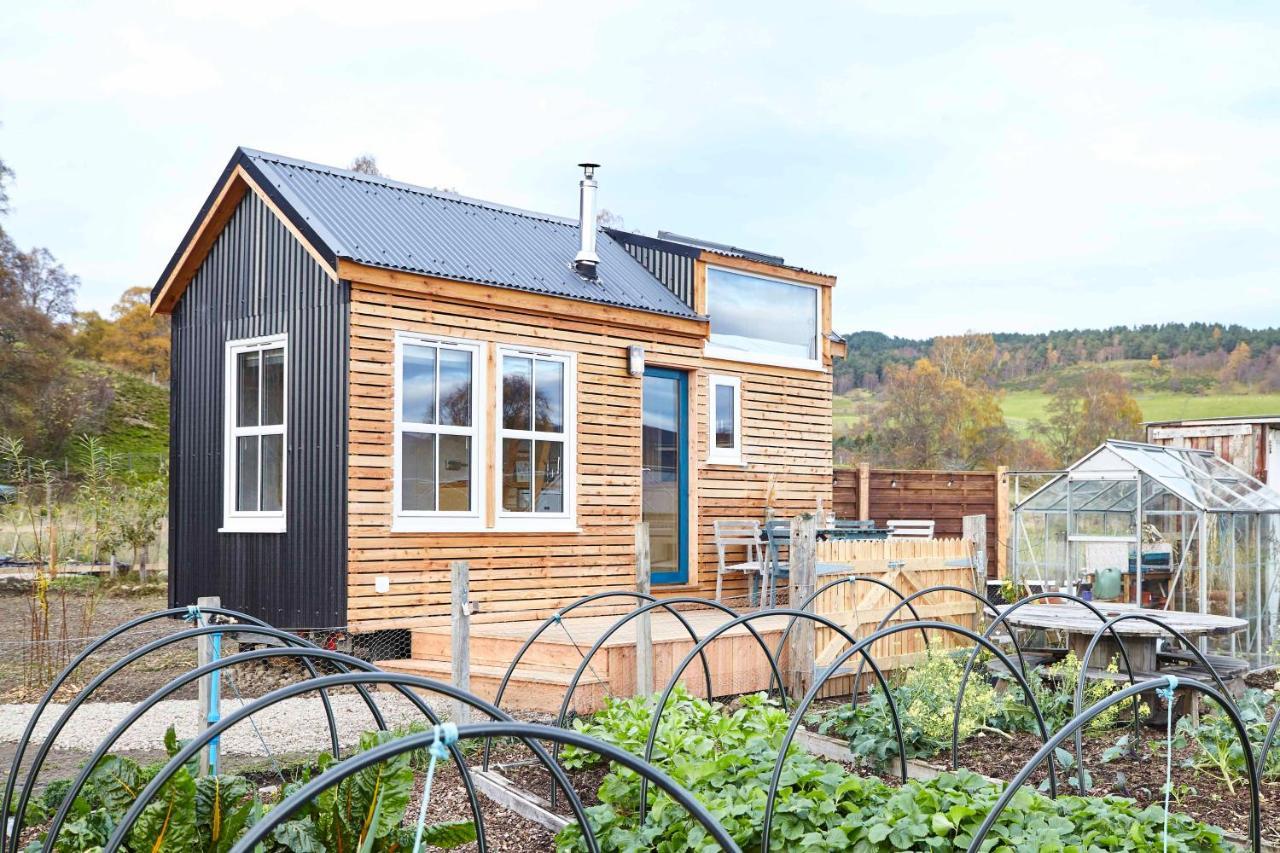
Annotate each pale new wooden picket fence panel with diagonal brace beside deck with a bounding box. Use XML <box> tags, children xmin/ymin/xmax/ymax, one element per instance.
<box><xmin>814</xmin><ymin>538</ymin><xmax>980</xmax><ymax>693</ymax></box>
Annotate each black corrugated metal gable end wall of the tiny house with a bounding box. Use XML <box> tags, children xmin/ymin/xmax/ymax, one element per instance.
<box><xmin>169</xmin><ymin>192</ymin><xmax>351</xmax><ymax>629</ymax></box>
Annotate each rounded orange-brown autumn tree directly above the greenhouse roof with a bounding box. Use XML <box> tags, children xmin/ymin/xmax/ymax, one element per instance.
<box><xmin>1036</xmin><ymin>368</ymin><xmax>1142</xmax><ymax>465</ymax></box>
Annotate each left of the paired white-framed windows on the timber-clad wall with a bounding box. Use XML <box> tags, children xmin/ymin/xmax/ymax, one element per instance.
<box><xmin>392</xmin><ymin>332</ymin><xmax>484</xmax><ymax>532</ymax></box>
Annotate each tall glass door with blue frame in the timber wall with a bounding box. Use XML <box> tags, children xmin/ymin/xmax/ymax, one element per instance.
<box><xmin>641</xmin><ymin>368</ymin><xmax>689</xmax><ymax>584</ymax></box>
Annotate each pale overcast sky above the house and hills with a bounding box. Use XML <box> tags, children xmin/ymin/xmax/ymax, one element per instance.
<box><xmin>0</xmin><ymin>0</ymin><xmax>1280</xmax><ymax>336</ymax></box>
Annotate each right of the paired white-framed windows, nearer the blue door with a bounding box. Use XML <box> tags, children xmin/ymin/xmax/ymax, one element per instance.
<box><xmin>495</xmin><ymin>347</ymin><xmax>577</xmax><ymax>530</ymax></box>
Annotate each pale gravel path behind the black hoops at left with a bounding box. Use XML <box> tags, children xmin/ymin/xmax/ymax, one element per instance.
<box><xmin>0</xmin><ymin>693</ymin><xmax>435</xmax><ymax>754</ymax></box>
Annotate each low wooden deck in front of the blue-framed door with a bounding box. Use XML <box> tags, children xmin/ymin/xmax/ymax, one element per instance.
<box><xmin>379</xmin><ymin>610</ymin><xmax>787</xmax><ymax>713</ymax></box>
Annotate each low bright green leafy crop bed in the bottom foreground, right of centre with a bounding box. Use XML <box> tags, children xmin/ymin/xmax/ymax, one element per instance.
<box><xmin>556</xmin><ymin>699</ymin><xmax>1229</xmax><ymax>853</ymax></box>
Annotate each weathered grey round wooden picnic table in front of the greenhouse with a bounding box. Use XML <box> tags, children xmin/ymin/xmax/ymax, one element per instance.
<box><xmin>1000</xmin><ymin>602</ymin><xmax>1249</xmax><ymax>675</ymax></box>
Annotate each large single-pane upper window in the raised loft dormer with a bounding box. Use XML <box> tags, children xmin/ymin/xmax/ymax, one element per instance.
<box><xmin>705</xmin><ymin>266</ymin><xmax>823</xmax><ymax>370</ymax></box>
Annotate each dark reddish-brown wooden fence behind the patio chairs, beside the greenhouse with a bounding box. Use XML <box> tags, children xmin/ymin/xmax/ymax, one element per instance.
<box><xmin>832</xmin><ymin>466</ymin><xmax>1009</xmax><ymax>578</ymax></box>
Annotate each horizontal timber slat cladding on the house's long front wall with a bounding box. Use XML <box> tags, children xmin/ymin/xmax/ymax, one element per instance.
<box><xmin>347</xmin><ymin>279</ymin><xmax>831</xmax><ymax>630</ymax></box>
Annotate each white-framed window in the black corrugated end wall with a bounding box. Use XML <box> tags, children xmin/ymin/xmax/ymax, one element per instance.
<box><xmin>221</xmin><ymin>334</ymin><xmax>289</xmax><ymax>533</ymax></box>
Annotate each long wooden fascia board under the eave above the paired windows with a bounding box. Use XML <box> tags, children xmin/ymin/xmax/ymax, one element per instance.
<box><xmin>338</xmin><ymin>259</ymin><xmax>709</xmax><ymax>339</ymax></box>
